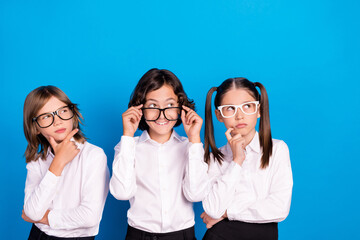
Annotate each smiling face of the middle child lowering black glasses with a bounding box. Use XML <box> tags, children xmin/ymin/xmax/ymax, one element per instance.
<box><xmin>144</xmin><ymin>84</ymin><xmax>179</xmax><ymax>143</ymax></box>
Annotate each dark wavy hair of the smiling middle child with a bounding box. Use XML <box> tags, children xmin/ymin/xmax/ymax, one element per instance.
<box><xmin>128</xmin><ymin>68</ymin><xmax>195</xmax><ymax>131</ymax></box>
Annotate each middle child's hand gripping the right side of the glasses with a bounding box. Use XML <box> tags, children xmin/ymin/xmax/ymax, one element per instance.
<box><xmin>181</xmin><ymin>106</ymin><xmax>203</xmax><ymax>143</ymax></box>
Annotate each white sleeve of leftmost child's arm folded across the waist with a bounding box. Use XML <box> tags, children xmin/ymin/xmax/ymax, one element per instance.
<box><xmin>48</xmin><ymin>148</ymin><xmax>109</xmax><ymax>229</ymax></box>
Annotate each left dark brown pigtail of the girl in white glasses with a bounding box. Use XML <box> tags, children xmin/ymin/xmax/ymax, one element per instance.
<box><xmin>204</xmin><ymin>87</ymin><xmax>224</xmax><ymax>164</ymax></box>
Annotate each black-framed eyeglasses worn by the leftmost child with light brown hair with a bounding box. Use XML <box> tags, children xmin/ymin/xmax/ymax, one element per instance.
<box><xmin>33</xmin><ymin>105</ymin><xmax>74</xmax><ymax>128</ymax></box>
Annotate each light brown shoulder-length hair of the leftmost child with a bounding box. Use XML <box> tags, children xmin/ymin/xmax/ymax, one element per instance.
<box><xmin>23</xmin><ymin>86</ymin><xmax>86</xmax><ymax>163</ymax></box>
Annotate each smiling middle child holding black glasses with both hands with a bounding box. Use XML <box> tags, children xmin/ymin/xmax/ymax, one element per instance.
<box><xmin>110</xmin><ymin>69</ymin><xmax>207</xmax><ymax>240</ymax></box>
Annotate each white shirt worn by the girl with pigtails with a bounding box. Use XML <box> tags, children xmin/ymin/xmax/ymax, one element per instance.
<box><xmin>203</xmin><ymin>132</ymin><xmax>293</xmax><ymax>223</ymax></box>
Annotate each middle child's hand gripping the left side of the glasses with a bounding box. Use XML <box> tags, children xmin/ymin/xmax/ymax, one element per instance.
<box><xmin>122</xmin><ymin>104</ymin><xmax>143</xmax><ymax>137</ymax></box>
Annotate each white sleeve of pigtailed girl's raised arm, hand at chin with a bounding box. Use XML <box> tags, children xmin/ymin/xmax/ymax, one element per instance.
<box><xmin>203</xmin><ymin>158</ymin><xmax>252</xmax><ymax>219</ymax></box>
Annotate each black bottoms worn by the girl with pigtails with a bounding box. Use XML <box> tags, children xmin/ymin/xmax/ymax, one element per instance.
<box><xmin>203</xmin><ymin>218</ymin><xmax>278</xmax><ymax>240</ymax></box>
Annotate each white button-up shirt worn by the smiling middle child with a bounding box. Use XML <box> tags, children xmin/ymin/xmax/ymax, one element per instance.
<box><xmin>110</xmin><ymin>130</ymin><xmax>207</xmax><ymax>233</ymax></box>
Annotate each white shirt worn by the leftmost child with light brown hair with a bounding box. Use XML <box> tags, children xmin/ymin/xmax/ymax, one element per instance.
<box><xmin>24</xmin><ymin>142</ymin><xmax>109</xmax><ymax>237</ymax></box>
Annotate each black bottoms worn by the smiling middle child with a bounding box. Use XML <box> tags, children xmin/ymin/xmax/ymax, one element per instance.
<box><xmin>125</xmin><ymin>225</ymin><xmax>196</xmax><ymax>240</ymax></box>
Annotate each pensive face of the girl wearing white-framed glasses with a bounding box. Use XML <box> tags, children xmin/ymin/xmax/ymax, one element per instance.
<box><xmin>215</xmin><ymin>89</ymin><xmax>260</xmax><ymax>140</ymax></box>
